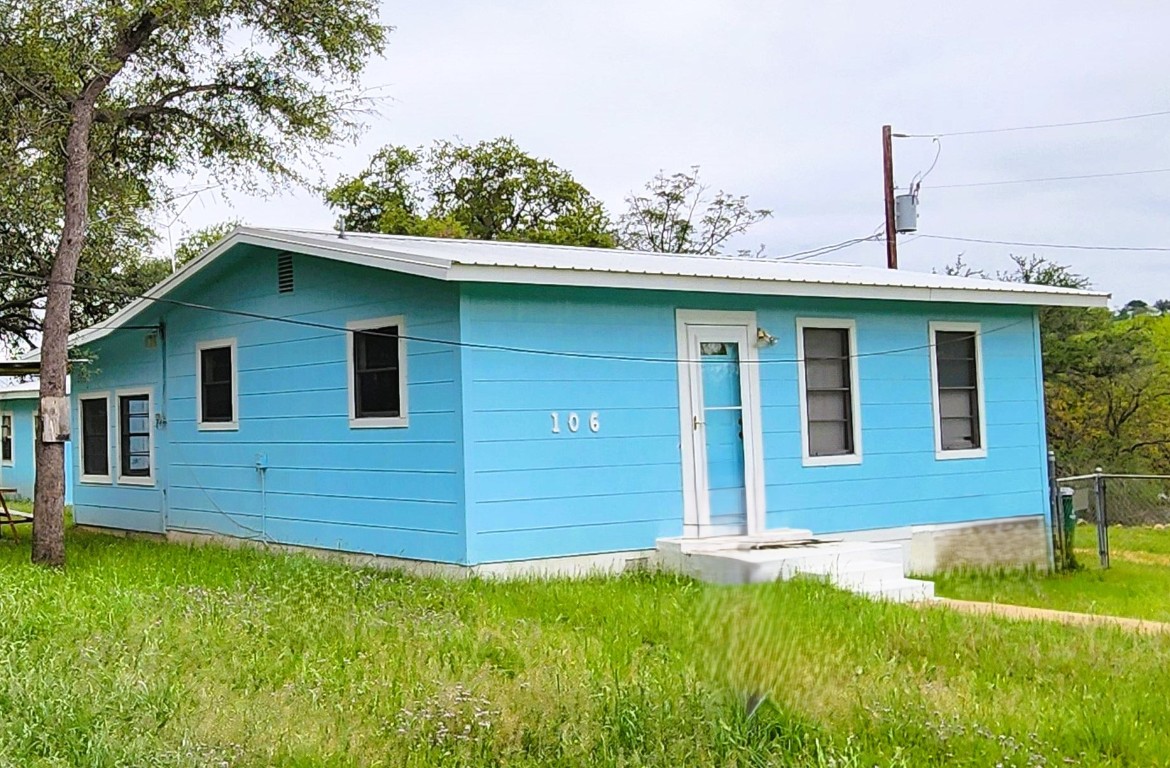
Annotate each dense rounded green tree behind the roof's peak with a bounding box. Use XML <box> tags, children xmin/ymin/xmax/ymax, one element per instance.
<box><xmin>325</xmin><ymin>137</ymin><xmax>614</xmax><ymax>247</ymax></box>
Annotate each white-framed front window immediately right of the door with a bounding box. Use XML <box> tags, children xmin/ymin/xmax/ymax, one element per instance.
<box><xmin>797</xmin><ymin>318</ymin><xmax>861</xmax><ymax>466</ymax></box>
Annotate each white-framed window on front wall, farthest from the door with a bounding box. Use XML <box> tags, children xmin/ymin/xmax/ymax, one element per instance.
<box><xmin>930</xmin><ymin>323</ymin><xmax>986</xmax><ymax>459</ymax></box>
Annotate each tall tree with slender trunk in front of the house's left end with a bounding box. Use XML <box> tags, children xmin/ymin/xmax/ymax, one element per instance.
<box><xmin>0</xmin><ymin>0</ymin><xmax>387</xmax><ymax>565</ymax></box>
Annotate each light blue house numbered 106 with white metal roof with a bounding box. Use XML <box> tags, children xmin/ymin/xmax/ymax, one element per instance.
<box><xmin>61</xmin><ymin>228</ymin><xmax>1108</xmax><ymax>570</ymax></box>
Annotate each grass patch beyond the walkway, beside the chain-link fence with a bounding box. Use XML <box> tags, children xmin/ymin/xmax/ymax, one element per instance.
<box><xmin>935</xmin><ymin>526</ymin><xmax>1170</xmax><ymax>622</ymax></box>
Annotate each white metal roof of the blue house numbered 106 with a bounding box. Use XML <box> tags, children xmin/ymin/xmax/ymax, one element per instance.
<box><xmin>66</xmin><ymin>227</ymin><xmax>1109</xmax><ymax>344</ymax></box>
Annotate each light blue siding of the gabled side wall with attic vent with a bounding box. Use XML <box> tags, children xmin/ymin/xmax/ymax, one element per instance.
<box><xmin>129</xmin><ymin>251</ymin><xmax>464</xmax><ymax>562</ymax></box>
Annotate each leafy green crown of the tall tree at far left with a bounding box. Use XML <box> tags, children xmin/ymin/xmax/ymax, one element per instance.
<box><xmin>0</xmin><ymin>0</ymin><xmax>387</xmax><ymax>345</ymax></box>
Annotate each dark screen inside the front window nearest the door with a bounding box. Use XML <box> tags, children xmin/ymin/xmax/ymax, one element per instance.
<box><xmin>804</xmin><ymin>328</ymin><xmax>855</xmax><ymax>457</ymax></box>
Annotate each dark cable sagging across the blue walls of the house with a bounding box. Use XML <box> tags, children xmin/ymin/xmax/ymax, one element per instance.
<box><xmin>0</xmin><ymin>269</ymin><xmax>1032</xmax><ymax>365</ymax></box>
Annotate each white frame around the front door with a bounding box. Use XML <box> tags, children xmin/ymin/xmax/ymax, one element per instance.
<box><xmin>675</xmin><ymin>309</ymin><xmax>766</xmax><ymax>537</ymax></box>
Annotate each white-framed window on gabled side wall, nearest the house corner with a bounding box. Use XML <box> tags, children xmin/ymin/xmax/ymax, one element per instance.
<box><xmin>347</xmin><ymin>317</ymin><xmax>407</xmax><ymax>426</ymax></box>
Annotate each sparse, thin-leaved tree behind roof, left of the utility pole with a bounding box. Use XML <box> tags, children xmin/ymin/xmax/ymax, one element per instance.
<box><xmin>618</xmin><ymin>165</ymin><xmax>772</xmax><ymax>255</ymax></box>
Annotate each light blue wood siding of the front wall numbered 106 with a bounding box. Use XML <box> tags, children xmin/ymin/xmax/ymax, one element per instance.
<box><xmin>461</xmin><ymin>286</ymin><xmax>1046</xmax><ymax>562</ymax></box>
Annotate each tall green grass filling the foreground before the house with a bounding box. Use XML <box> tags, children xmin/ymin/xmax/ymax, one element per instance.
<box><xmin>0</xmin><ymin>532</ymin><xmax>1170</xmax><ymax>767</ymax></box>
